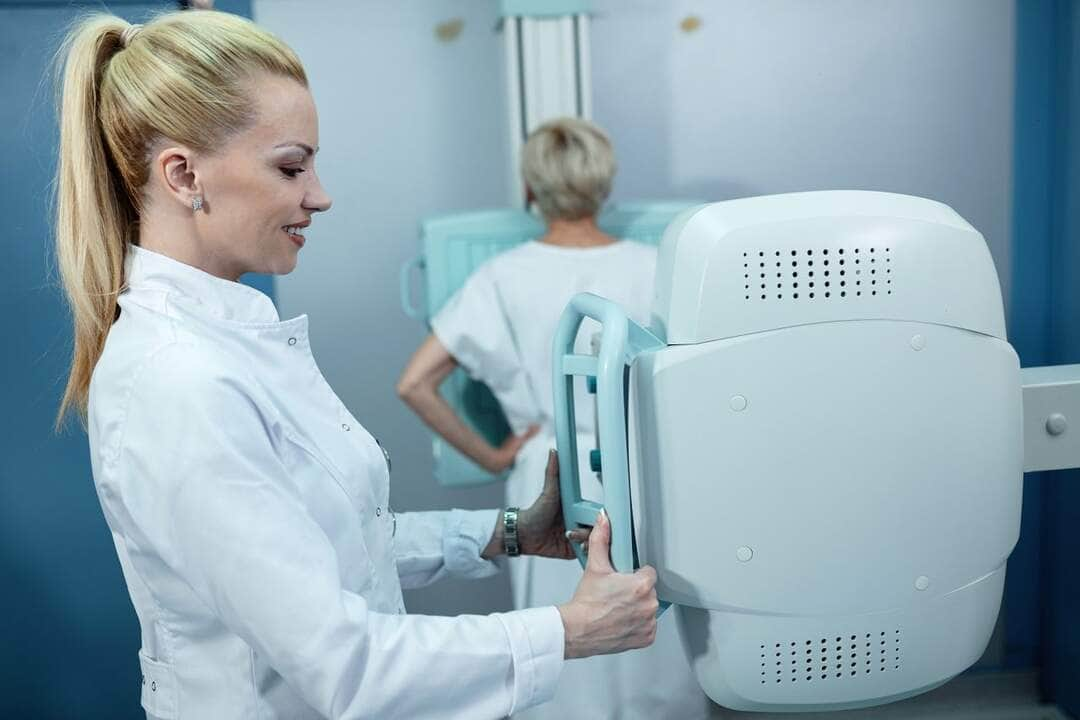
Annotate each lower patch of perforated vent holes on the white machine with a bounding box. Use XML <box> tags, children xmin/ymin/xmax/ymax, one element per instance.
<box><xmin>758</xmin><ymin>628</ymin><xmax>902</xmax><ymax>684</ymax></box>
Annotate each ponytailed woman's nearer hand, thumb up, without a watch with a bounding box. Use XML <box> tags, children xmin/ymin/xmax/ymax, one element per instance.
<box><xmin>558</xmin><ymin>513</ymin><xmax>659</xmax><ymax>660</ymax></box>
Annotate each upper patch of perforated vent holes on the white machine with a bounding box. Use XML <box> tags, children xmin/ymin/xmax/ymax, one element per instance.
<box><xmin>742</xmin><ymin>247</ymin><xmax>893</xmax><ymax>301</ymax></box>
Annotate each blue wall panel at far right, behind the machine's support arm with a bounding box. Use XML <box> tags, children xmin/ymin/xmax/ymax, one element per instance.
<box><xmin>1007</xmin><ymin>0</ymin><xmax>1080</xmax><ymax>716</ymax></box>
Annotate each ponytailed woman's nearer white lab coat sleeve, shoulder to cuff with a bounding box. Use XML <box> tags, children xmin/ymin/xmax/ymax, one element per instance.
<box><xmin>109</xmin><ymin>344</ymin><xmax>564</xmax><ymax>719</ymax></box>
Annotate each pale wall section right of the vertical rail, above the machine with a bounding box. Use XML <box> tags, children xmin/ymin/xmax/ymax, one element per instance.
<box><xmin>592</xmin><ymin>0</ymin><xmax>1015</xmax><ymax>297</ymax></box>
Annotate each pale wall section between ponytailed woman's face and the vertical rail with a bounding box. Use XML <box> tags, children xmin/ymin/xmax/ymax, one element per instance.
<box><xmin>253</xmin><ymin>0</ymin><xmax>518</xmax><ymax>613</ymax></box>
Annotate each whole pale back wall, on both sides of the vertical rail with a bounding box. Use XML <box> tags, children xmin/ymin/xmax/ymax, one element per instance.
<box><xmin>254</xmin><ymin>0</ymin><xmax>1014</xmax><ymax>613</ymax></box>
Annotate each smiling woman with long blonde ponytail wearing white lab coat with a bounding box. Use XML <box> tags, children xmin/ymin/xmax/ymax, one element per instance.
<box><xmin>56</xmin><ymin>12</ymin><xmax>657</xmax><ymax>720</ymax></box>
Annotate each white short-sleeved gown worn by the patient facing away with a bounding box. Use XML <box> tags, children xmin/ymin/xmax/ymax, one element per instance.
<box><xmin>432</xmin><ymin>241</ymin><xmax>712</xmax><ymax>720</ymax></box>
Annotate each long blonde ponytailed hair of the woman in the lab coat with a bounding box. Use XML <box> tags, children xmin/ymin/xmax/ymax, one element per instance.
<box><xmin>55</xmin><ymin>11</ymin><xmax>308</xmax><ymax>424</ymax></box>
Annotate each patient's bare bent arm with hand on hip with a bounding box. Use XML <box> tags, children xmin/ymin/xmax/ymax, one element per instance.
<box><xmin>397</xmin><ymin>335</ymin><xmax>538</xmax><ymax>473</ymax></box>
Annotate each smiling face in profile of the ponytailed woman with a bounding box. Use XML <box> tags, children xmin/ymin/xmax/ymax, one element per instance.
<box><xmin>195</xmin><ymin>74</ymin><xmax>330</xmax><ymax>280</ymax></box>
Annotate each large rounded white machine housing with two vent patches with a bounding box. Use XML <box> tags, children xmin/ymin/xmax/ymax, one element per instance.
<box><xmin>626</xmin><ymin>191</ymin><xmax>1024</xmax><ymax>710</ymax></box>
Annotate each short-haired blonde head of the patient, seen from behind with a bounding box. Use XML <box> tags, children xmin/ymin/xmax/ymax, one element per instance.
<box><xmin>522</xmin><ymin>118</ymin><xmax>616</xmax><ymax>220</ymax></box>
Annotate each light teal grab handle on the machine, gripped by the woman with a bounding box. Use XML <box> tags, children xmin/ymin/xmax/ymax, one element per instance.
<box><xmin>552</xmin><ymin>293</ymin><xmax>664</xmax><ymax>572</ymax></box>
